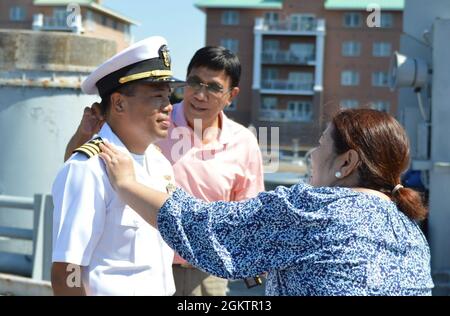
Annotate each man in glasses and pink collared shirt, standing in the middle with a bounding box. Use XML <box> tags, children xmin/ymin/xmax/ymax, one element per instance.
<box><xmin>67</xmin><ymin>46</ymin><xmax>264</xmax><ymax>296</ymax></box>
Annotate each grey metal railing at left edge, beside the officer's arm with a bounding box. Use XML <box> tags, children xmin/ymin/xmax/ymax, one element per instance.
<box><xmin>0</xmin><ymin>194</ymin><xmax>53</xmax><ymax>280</ymax></box>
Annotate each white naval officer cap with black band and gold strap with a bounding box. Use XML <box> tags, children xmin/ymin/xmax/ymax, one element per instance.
<box><xmin>81</xmin><ymin>36</ymin><xmax>185</xmax><ymax>97</ymax></box>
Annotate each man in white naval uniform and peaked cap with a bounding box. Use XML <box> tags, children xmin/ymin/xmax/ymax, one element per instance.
<box><xmin>52</xmin><ymin>36</ymin><xmax>182</xmax><ymax>295</ymax></box>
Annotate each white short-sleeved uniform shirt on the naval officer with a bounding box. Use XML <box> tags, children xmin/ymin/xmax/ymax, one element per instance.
<box><xmin>52</xmin><ymin>124</ymin><xmax>175</xmax><ymax>295</ymax></box>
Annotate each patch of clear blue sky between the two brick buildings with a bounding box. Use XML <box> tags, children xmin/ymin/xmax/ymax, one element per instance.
<box><xmin>102</xmin><ymin>0</ymin><xmax>206</xmax><ymax>79</ymax></box>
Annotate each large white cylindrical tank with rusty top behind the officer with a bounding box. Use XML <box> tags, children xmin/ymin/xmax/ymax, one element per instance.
<box><xmin>0</xmin><ymin>30</ymin><xmax>116</xmax><ymax>269</ymax></box>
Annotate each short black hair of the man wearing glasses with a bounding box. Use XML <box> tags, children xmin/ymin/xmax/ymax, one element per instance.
<box><xmin>187</xmin><ymin>46</ymin><xmax>241</xmax><ymax>88</ymax></box>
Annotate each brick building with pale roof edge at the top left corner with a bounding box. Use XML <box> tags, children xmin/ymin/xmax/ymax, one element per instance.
<box><xmin>0</xmin><ymin>0</ymin><xmax>137</xmax><ymax>51</ymax></box>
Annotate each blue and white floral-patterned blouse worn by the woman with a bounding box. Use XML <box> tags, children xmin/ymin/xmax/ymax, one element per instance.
<box><xmin>158</xmin><ymin>183</ymin><xmax>433</xmax><ymax>295</ymax></box>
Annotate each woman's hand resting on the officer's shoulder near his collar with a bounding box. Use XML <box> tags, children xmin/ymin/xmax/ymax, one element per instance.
<box><xmin>100</xmin><ymin>142</ymin><xmax>136</xmax><ymax>191</ymax></box>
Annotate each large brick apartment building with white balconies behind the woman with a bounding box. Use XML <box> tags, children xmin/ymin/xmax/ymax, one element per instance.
<box><xmin>196</xmin><ymin>0</ymin><xmax>404</xmax><ymax>150</ymax></box>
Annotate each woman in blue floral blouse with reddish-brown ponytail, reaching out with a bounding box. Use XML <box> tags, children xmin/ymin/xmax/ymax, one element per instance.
<box><xmin>97</xmin><ymin>109</ymin><xmax>433</xmax><ymax>295</ymax></box>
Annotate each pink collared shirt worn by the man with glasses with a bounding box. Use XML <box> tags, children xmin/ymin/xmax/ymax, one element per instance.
<box><xmin>158</xmin><ymin>102</ymin><xmax>264</xmax><ymax>263</ymax></box>
